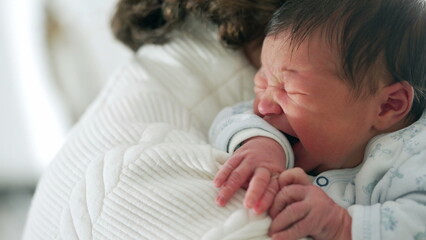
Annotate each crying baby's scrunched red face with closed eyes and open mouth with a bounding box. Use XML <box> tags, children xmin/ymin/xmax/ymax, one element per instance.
<box><xmin>254</xmin><ymin>32</ymin><xmax>379</xmax><ymax>172</ymax></box>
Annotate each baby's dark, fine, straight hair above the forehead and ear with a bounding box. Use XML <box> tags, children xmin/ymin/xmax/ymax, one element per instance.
<box><xmin>267</xmin><ymin>0</ymin><xmax>426</xmax><ymax>122</ymax></box>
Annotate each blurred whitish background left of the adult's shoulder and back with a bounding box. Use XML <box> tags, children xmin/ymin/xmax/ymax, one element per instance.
<box><xmin>0</xmin><ymin>0</ymin><xmax>131</xmax><ymax>237</ymax></box>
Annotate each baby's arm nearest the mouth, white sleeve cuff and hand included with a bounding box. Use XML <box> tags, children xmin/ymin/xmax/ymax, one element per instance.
<box><xmin>210</xmin><ymin>101</ymin><xmax>294</xmax><ymax>213</ymax></box>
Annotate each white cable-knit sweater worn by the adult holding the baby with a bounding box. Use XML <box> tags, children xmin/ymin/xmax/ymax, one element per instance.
<box><xmin>23</xmin><ymin>17</ymin><xmax>270</xmax><ymax>240</ymax></box>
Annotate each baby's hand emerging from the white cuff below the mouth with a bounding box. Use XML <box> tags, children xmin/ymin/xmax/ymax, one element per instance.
<box><xmin>214</xmin><ymin>137</ymin><xmax>286</xmax><ymax>214</ymax></box>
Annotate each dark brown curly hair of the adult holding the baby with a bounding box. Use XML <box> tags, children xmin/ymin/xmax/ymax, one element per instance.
<box><xmin>111</xmin><ymin>0</ymin><xmax>285</xmax><ymax>51</ymax></box>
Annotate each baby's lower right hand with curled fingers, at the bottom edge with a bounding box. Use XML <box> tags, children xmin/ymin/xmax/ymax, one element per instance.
<box><xmin>269</xmin><ymin>168</ymin><xmax>352</xmax><ymax>240</ymax></box>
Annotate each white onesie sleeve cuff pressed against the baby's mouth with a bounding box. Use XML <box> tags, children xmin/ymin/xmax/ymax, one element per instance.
<box><xmin>209</xmin><ymin>101</ymin><xmax>294</xmax><ymax>169</ymax></box>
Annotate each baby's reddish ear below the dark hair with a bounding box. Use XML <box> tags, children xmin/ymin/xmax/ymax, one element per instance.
<box><xmin>374</xmin><ymin>81</ymin><xmax>414</xmax><ymax>131</ymax></box>
